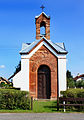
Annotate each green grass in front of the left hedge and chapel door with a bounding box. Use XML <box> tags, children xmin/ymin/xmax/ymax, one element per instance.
<box><xmin>0</xmin><ymin>101</ymin><xmax>57</xmax><ymax>113</ymax></box>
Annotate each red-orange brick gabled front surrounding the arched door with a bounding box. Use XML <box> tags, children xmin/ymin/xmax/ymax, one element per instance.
<box><xmin>29</xmin><ymin>46</ymin><xmax>58</xmax><ymax>98</ymax></box>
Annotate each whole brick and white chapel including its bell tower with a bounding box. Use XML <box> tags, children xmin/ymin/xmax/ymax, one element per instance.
<box><xmin>13</xmin><ymin>12</ymin><xmax>67</xmax><ymax>99</ymax></box>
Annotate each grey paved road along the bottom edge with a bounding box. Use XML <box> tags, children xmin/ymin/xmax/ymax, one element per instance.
<box><xmin>0</xmin><ymin>113</ymin><xmax>84</xmax><ymax>120</ymax></box>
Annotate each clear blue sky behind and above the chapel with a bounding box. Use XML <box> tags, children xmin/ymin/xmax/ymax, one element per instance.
<box><xmin>0</xmin><ymin>0</ymin><xmax>84</xmax><ymax>78</ymax></box>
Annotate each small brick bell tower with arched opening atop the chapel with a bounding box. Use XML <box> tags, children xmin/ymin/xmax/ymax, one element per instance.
<box><xmin>35</xmin><ymin>9</ymin><xmax>50</xmax><ymax>40</ymax></box>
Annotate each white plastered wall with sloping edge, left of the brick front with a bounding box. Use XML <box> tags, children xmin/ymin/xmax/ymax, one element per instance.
<box><xmin>13</xmin><ymin>59</ymin><xmax>29</xmax><ymax>91</ymax></box>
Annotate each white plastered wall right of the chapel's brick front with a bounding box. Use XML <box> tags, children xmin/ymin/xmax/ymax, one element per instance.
<box><xmin>58</xmin><ymin>58</ymin><xmax>67</xmax><ymax>96</ymax></box>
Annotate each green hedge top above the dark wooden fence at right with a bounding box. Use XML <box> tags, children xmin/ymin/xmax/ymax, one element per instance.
<box><xmin>61</xmin><ymin>88</ymin><xmax>84</xmax><ymax>98</ymax></box>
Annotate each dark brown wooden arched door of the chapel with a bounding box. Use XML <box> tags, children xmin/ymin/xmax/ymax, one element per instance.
<box><xmin>38</xmin><ymin>65</ymin><xmax>51</xmax><ymax>99</ymax></box>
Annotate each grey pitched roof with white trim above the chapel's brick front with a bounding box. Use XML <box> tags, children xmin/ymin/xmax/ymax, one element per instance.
<box><xmin>20</xmin><ymin>37</ymin><xmax>67</xmax><ymax>54</ymax></box>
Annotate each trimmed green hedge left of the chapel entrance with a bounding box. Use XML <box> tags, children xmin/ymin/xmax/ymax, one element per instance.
<box><xmin>0</xmin><ymin>89</ymin><xmax>30</xmax><ymax>110</ymax></box>
